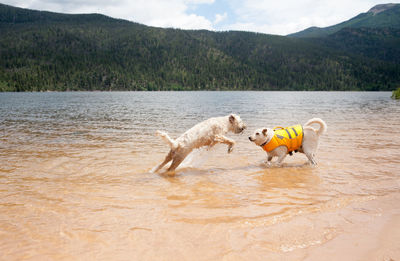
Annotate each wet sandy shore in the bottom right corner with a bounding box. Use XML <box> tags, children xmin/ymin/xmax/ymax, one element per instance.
<box><xmin>302</xmin><ymin>193</ymin><xmax>400</xmax><ymax>261</ymax></box>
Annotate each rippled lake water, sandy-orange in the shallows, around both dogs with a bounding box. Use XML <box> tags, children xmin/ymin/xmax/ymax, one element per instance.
<box><xmin>0</xmin><ymin>92</ymin><xmax>400</xmax><ymax>260</ymax></box>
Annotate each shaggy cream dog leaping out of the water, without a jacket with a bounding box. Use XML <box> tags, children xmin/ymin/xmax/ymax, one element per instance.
<box><xmin>154</xmin><ymin>114</ymin><xmax>246</xmax><ymax>172</ymax></box>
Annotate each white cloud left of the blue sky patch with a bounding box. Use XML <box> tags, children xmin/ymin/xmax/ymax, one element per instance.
<box><xmin>3</xmin><ymin>0</ymin><xmax>215</xmax><ymax>30</ymax></box>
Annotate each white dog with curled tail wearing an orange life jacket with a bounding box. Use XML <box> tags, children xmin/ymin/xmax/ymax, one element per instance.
<box><xmin>249</xmin><ymin>118</ymin><xmax>327</xmax><ymax>165</ymax></box>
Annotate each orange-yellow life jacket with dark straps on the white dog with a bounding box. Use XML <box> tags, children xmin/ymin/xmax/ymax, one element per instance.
<box><xmin>261</xmin><ymin>124</ymin><xmax>303</xmax><ymax>153</ymax></box>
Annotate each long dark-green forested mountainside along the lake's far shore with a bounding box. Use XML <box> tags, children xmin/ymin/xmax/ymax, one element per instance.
<box><xmin>0</xmin><ymin>4</ymin><xmax>400</xmax><ymax>91</ymax></box>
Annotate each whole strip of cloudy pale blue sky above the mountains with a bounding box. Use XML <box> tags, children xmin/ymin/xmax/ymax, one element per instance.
<box><xmin>0</xmin><ymin>0</ymin><xmax>400</xmax><ymax>35</ymax></box>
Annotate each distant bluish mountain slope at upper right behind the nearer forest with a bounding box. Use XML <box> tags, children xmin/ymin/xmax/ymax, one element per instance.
<box><xmin>289</xmin><ymin>4</ymin><xmax>400</xmax><ymax>63</ymax></box>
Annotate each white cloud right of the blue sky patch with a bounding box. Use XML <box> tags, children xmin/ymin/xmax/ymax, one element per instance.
<box><xmin>228</xmin><ymin>0</ymin><xmax>399</xmax><ymax>35</ymax></box>
